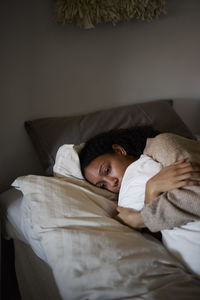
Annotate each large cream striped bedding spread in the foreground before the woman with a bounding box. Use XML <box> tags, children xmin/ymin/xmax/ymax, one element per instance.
<box><xmin>13</xmin><ymin>175</ymin><xmax>200</xmax><ymax>300</ymax></box>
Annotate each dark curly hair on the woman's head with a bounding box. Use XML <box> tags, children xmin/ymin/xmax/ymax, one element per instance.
<box><xmin>79</xmin><ymin>126</ymin><xmax>160</xmax><ymax>176</ymax></box>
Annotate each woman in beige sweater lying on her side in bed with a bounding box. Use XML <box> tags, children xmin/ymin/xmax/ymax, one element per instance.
<box><xmin>79</xmin><ymin>126</ymin><xmax>200</xmax><ymax>232</ymax></box>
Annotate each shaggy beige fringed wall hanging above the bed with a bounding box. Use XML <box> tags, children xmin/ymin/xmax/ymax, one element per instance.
<box><xmin>54</xmin><ymin>0</ymin><xmax>166</xmax><ymax>29</ymax></box>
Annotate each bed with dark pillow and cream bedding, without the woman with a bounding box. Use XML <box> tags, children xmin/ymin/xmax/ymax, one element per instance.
<box><xmin>0</xmin><ymin>100</ymin><xmax>200</xmax><ymax>300</ymax></box>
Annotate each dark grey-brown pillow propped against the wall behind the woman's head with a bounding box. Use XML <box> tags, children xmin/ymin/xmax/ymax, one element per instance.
<box><xmin>25</xmin><ymin>100</ymin><xmax>193</xmax><ymax>175</ymax></box>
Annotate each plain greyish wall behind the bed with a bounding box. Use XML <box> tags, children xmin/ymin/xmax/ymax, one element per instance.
<box><xmin>0</xmin><ymin>0</ymin><xmax>200</xmax><ymax>190</ymax></box>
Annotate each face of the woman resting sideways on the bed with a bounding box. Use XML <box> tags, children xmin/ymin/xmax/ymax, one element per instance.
<box><xmin>85</xmin><ymin>148</ymin><xmax>135</xmax><ymax>193</ymax></box>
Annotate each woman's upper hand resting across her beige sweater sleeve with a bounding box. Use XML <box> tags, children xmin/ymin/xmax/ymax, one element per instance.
<box><xmin>145</xmin><ymin>159</ymin><xmax>200</xmax><ymax>203</ymax></box>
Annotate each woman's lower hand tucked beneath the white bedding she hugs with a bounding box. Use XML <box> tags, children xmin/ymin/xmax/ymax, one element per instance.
<box><xmin>116</xmin><ymin>206</ymin><xmax>145</xmax><ymax>228</ymax></box>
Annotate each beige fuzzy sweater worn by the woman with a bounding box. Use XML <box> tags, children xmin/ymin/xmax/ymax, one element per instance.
<box><xmin>141</xmin><ymin>133</ymin><xmax>200</xmax><ymax>232</ymax></box>
